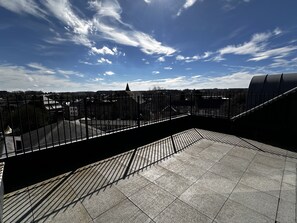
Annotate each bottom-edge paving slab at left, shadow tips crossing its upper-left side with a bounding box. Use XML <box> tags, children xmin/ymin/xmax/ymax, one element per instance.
<box><xmin>34</xmin><ymin>202</ymin><xmax>92</xmax><ymax>223</ymax></box>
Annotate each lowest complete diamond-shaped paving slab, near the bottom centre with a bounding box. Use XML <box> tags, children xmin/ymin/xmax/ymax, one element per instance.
<box><xmin>130</xmin><ymin>183</ymin><xmax>175</xmax><ymax>219</ymax></box>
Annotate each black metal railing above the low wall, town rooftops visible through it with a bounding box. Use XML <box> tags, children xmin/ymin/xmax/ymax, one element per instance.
<box><xmin>0</xmin><ymin>89</ymin><xmax>247</xmax><ymax>159</ymax></box>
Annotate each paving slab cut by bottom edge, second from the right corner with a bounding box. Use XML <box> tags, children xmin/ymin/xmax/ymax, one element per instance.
<box><xmin>215</xmin><ymin>200</ymin><xmax>274</xmax><ymax>223</ymax></box>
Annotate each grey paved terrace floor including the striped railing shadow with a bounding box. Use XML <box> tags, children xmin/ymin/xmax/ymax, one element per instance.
<box><xmin>3</xmin><ymin>129</ymin><xmax>297</xmax><ymax>223</ymax></box>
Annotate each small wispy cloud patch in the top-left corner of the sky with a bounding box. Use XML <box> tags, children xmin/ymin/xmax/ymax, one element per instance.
<box><xmin>0</xmin><ymin>0</ymin><xmax>47</xmax><ymax>18</ymax></box>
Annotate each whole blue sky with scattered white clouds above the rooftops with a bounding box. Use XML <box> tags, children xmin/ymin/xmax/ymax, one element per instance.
<box><xmin>0</xmin><ymin>0</ymin><xmax>297</xmax><ymax>91</ymax></box>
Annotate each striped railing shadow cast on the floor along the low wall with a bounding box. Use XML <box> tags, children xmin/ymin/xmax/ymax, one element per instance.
<box><xmin>3</xmin><ymin>129</ymin><xmax>202</xmax><ymax>222</ymax></box>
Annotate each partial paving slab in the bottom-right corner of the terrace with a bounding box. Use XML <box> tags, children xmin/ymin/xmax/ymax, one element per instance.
<box><xmin>276</xmin><ymin>199</ymin><xmax>296</xmax><ymax>223</ymax></box>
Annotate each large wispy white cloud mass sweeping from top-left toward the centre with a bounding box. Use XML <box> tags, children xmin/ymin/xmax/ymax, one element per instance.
<box><xmin>0</xmin><ymin>0</ymin><xmax>176</xmax><ymax>55</ymax></box>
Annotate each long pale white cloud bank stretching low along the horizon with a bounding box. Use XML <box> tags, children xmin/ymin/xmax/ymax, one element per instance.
<box><xmin>0</xmin><ymin>61</ymin><xmax>260</xmax><ymax>92</ymax></box>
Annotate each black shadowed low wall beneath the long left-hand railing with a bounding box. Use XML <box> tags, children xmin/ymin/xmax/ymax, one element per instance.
<box><xmin>4</xmin><ymin>116</ymin><xmax>193</xmax><ymax>193</ymax></box>
